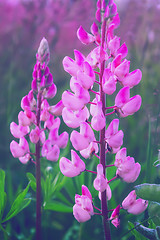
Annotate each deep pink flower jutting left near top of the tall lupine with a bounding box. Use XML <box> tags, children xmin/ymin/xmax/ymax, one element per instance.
<box><xmin>77</xmin><ymin>26</ymin><xmax>95</xmax><ymax>44</ymax></box>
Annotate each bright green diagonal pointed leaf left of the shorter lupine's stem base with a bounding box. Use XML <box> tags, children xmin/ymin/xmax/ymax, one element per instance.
<box><xmin>2</xmin><ymin>182</ymin><xmax>31</xmax><ymax>223</ymax></box>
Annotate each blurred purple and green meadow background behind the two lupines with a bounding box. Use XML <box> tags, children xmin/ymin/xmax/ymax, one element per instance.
<box><xmin>0</xmin><ymin>0</ymin><xmax>160</xmax><ymax>240</ymax></box>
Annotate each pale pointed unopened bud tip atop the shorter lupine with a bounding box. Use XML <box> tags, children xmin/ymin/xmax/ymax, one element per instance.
<box><xmin>37</xmin><ymin>38</ymin><xmax>50</xmax><ymax>65</ymax></box>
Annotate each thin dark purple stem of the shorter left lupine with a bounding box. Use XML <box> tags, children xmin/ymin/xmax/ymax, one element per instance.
<box><xmin>35</xmin><ymin>92</ymin><xmax>41</xmax><ymax>240</ymax></box>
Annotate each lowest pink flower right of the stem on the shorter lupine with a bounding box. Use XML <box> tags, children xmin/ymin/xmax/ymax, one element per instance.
<box><xmin>41</xmin><ymin>139</ymin><xmax>60</xmax><ymax>162</ymax></box>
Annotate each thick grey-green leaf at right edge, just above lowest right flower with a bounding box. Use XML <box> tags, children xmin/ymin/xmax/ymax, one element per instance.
<box><xmin>135</xmin><ymin>183</ymin><xmax>160</xmax><ymax>202</ymax></box>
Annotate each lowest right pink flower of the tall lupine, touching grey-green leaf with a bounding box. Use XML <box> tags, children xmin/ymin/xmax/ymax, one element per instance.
<box><xmin>122</xmin><ymin>190</ymin><xmax>148</xmax><ymax>215</ymax></box>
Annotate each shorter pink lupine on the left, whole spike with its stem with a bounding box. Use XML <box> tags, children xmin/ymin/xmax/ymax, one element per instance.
<box><xmin>10</xmin><ymin>38</ymin><xmax>68</xmax><ymax>240</ymax></box>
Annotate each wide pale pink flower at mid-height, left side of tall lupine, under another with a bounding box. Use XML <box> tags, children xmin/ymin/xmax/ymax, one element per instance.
<box><xmin>62</xmin><ymin>107</ymin><xmax>89</xmax><ymax>128</ymax></box>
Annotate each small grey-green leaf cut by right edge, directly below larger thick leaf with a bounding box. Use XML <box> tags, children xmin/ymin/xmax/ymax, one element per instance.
<box><xmin>148</xmin><ymin>202</ymin><xmax>160</xmax><ymax>226</ymax></box>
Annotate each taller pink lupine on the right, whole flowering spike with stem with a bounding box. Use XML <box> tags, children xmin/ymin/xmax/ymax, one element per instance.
<box><xmin>60</xmin><ymin>0</ymin><xmax>148</xmax><ymax>240</ymax></box>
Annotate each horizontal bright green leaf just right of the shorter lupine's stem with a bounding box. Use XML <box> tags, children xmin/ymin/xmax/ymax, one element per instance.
<box><xmin>44</xmin><ymin>201</ymin><xmax>73</xmax><ymax>213</ymax></box>
